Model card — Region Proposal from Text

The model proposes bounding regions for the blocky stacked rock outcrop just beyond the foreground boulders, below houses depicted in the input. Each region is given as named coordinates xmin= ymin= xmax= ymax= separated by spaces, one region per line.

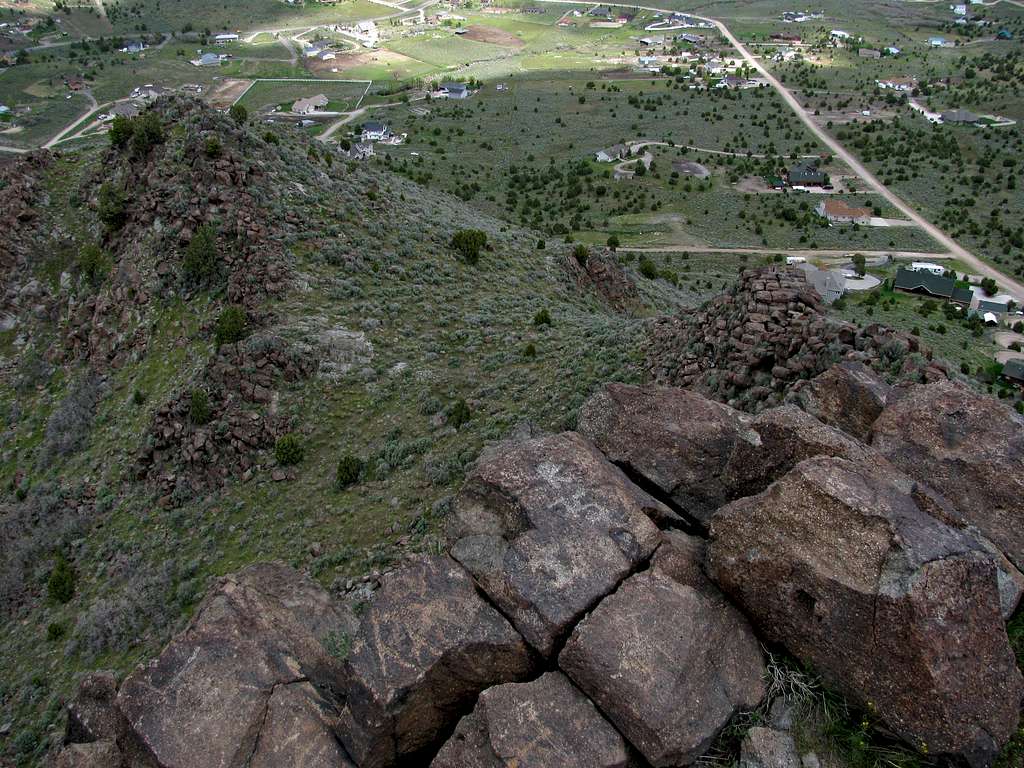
xmin=647 ymin=267 xmax=946 ymax=412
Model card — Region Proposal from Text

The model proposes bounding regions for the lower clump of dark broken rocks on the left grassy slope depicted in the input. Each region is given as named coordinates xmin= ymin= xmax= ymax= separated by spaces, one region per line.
xmin=136 ymin=334 xmax=317 ymax=495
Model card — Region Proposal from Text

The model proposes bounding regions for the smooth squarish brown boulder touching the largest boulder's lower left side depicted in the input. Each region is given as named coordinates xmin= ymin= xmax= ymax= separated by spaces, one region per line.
xmin=558 ymin=540 xmax=765 ymax=768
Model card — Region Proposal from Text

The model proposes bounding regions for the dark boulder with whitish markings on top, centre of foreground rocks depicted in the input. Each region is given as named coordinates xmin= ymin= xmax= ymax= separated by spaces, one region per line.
xmin=449 ymin=432 xmax=671 ymax=656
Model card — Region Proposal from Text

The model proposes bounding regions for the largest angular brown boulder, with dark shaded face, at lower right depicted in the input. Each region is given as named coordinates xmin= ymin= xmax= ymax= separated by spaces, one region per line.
xmin=709 ymin=458 xmax=1024 ymax=766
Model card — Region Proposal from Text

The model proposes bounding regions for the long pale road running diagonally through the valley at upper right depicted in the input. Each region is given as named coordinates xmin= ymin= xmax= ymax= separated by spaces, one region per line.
xmin=538 ymin=0 xmax=1024 ymax=301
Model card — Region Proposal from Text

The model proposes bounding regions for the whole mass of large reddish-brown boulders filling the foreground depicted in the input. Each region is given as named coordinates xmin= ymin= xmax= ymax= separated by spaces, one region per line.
xmin=57 ymin=360 xmax=1024 ymax=768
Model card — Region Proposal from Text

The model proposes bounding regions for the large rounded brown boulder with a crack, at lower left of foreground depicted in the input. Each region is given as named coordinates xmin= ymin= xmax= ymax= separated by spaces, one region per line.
xmin=118 ymin=563 xmax=355 ymax=768
